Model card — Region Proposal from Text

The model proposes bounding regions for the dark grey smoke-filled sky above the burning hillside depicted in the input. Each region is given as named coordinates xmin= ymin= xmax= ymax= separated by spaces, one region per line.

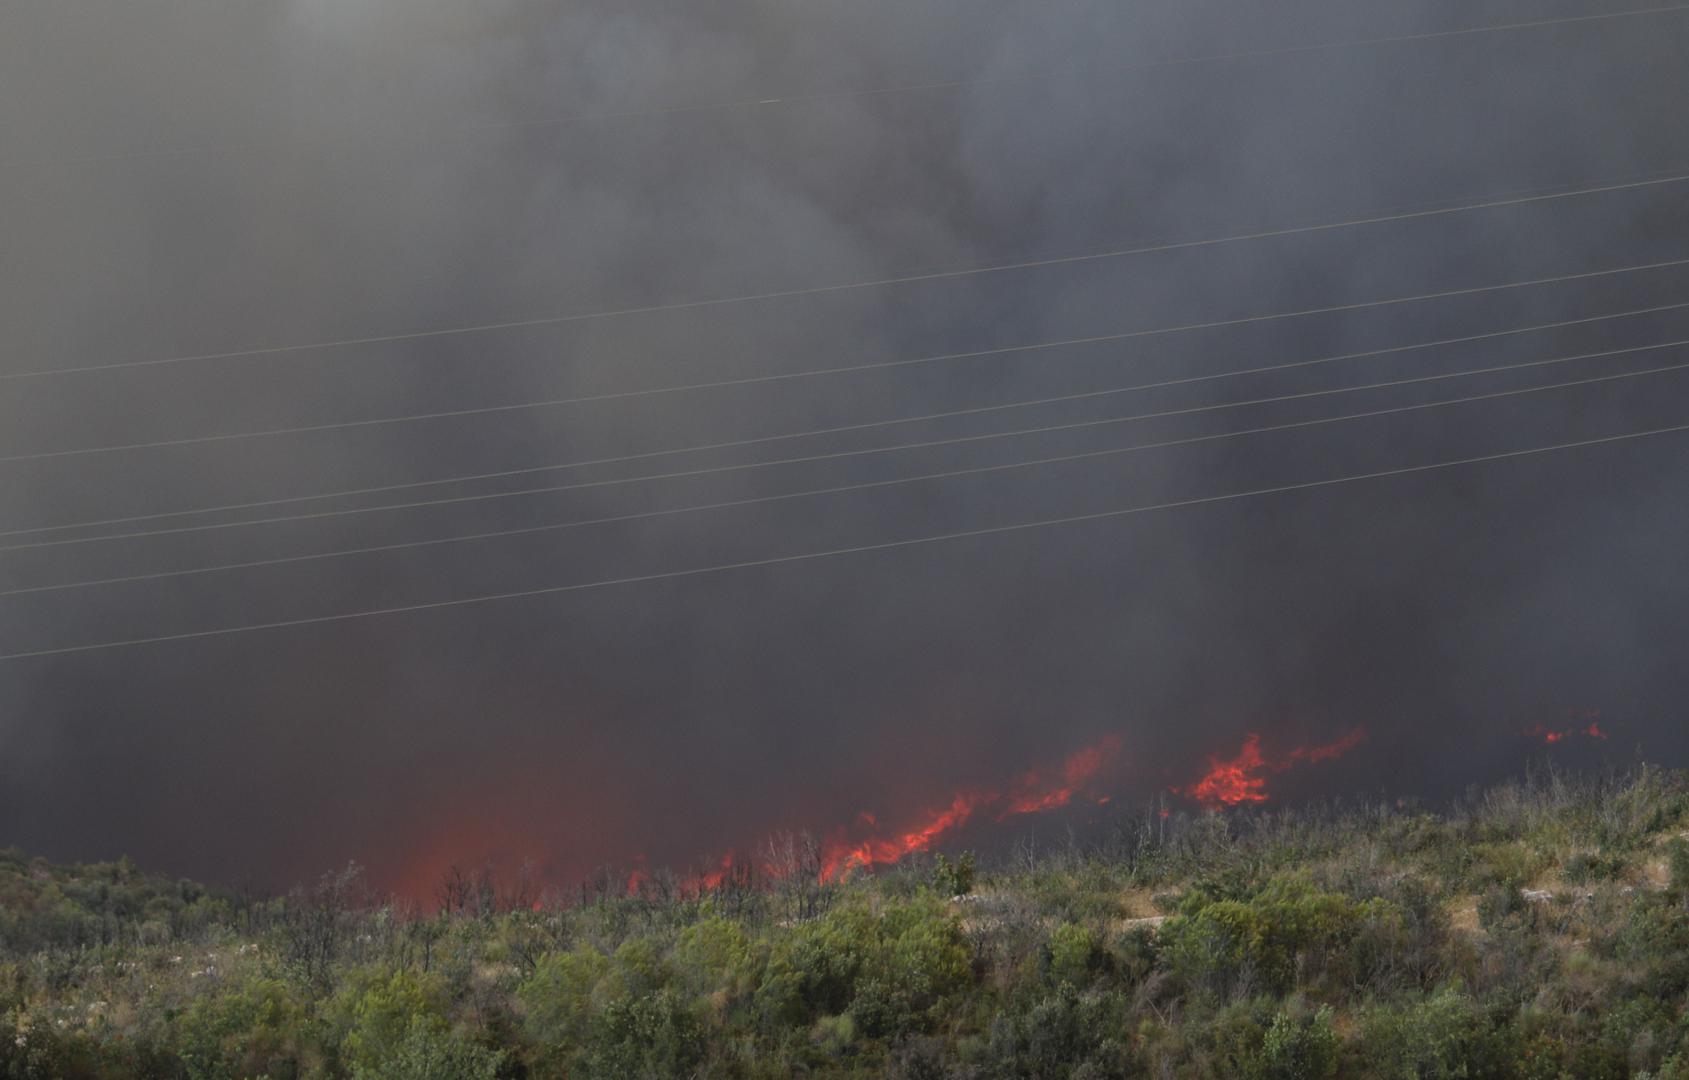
xmin=0 ymin=0 xmax=1689 ymax=894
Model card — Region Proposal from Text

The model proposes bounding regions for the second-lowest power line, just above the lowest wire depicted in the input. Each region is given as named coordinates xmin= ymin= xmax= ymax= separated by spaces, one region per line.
xmin=0 ymin=351 xmax=1689 ymax=597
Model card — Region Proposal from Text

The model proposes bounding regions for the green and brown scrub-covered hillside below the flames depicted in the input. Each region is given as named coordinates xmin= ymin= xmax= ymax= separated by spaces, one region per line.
xmin=0 ymin=767 xmax=1689 ymax=1080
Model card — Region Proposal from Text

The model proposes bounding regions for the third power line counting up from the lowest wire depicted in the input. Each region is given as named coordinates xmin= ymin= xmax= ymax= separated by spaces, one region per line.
xmin=13 ymin=335 xmax=1689 ymax=553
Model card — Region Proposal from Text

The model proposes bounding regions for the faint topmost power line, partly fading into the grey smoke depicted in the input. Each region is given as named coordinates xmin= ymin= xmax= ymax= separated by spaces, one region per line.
xmin=0 ymin=3 xmax=1689 ymax=169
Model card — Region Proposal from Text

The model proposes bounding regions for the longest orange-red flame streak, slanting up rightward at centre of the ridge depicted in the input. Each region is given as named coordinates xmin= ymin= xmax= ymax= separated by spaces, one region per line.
xmin=821 ymin=735 xmax=1121 ymax=881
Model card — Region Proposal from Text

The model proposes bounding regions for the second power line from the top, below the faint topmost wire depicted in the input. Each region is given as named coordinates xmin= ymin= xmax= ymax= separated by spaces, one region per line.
xmin=0 ymin=172 xmax=1689 ymax=380
